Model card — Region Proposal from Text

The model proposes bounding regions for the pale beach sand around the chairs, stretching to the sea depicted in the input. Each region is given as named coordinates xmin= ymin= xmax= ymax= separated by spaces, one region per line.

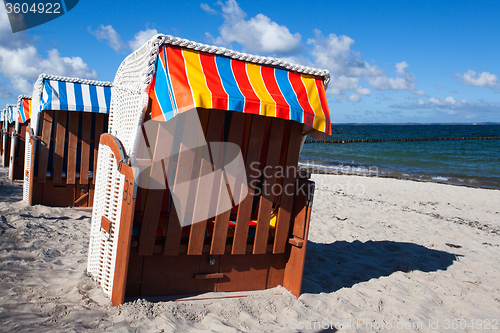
xmin=0 ymin=168 xmax=500 ymax=332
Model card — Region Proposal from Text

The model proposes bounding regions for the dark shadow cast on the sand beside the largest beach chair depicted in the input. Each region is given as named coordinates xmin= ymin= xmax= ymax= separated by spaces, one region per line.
xmin=302 ymin=241 xmax=456 ymax=293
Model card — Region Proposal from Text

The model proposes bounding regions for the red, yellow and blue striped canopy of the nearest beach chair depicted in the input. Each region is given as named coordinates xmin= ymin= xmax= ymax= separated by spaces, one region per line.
xmin=149 ymin=44 xmax=331 ymax=135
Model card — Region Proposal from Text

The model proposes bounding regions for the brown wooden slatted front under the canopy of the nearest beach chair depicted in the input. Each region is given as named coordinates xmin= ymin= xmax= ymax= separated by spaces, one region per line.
xmin=136 ymin=109 xmax=302 ymax=255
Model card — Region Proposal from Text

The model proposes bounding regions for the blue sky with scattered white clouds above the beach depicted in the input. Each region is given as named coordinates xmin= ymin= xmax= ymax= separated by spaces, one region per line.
xmin=0 ymin=0 xmax=500 ymax=123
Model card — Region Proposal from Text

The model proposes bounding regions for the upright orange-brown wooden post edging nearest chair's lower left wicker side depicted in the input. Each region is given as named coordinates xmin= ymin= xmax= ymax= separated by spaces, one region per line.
xmin=111 ymin=163 xmax=135 ymax=306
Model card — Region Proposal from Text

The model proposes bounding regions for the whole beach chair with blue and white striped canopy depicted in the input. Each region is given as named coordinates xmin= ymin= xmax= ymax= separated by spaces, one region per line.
xmin=23 ymin=74 xmax=111 ymax=207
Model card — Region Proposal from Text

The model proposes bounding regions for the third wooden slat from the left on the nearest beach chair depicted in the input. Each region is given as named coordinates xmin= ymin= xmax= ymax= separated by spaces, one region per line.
xmin=187 ymin=110 xmax=213 ymax=255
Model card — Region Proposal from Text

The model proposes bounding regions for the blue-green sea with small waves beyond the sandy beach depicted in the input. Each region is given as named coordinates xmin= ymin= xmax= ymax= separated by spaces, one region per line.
xmin=299 ymin=124 xmax=500 ymax=189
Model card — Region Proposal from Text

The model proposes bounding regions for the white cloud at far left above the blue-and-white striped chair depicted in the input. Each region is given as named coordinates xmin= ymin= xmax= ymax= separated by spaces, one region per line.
xmin=0 ymin=11 xmax=97 ymax=97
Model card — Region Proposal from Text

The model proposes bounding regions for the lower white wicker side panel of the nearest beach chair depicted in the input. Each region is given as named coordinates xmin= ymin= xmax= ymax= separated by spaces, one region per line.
xmin=87 ymin=144 xmax=125 ymax=298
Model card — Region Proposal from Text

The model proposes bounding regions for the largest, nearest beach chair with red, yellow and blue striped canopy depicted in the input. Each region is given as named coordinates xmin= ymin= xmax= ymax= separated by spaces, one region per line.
xmin=87 ymin=35 xmax=331 ymax=305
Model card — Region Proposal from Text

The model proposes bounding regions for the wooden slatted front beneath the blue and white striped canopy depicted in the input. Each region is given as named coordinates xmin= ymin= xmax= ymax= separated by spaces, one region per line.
xmin=35 ymin=110 xmax=109 ymax=184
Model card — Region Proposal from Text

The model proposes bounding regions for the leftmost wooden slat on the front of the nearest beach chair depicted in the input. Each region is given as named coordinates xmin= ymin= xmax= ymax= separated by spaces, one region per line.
xmin=139 ymin=119 xmax=173 ymax=256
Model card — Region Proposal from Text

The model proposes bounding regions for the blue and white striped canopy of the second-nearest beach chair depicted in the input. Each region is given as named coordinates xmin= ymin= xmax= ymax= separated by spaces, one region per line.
xmin=40 ymin=79 xmax=111 ymax=114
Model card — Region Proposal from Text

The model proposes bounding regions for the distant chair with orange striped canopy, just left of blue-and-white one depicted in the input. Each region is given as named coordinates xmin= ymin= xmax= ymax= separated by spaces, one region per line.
xmin=9 ymin=95 xmax=31 ymax=182
